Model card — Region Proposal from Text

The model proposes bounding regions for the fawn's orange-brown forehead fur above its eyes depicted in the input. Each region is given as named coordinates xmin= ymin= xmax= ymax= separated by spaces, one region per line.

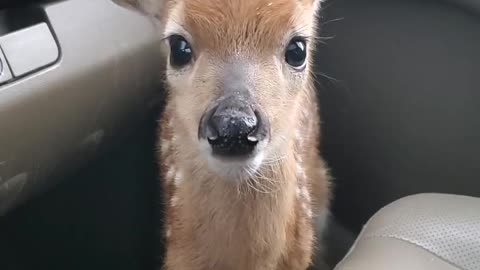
xmin=165 ymin=0 xmax=313 ymax=53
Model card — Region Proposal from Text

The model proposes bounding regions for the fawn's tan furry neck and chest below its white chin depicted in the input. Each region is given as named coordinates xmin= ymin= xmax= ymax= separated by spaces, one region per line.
xmin=162 ymin=88 xmax=313 ymax=269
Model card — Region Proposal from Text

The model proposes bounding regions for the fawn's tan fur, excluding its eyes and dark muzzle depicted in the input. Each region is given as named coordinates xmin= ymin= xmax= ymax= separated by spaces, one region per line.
xmin=115 ymin=0 xmax=330 ymax=270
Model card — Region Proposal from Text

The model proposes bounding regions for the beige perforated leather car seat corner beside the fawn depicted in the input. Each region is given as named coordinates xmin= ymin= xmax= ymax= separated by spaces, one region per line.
xmin=335 ymin=194 xmax=480 ymax=270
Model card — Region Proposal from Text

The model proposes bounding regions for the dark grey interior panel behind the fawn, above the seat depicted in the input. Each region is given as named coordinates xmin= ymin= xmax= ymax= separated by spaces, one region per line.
xmin=317 ymin=0 xmax=480 ymax=232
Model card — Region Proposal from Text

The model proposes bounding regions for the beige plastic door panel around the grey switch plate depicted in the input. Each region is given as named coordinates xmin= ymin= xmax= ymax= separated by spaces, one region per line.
xmin=0 ymin=0 xmax=164 ymax=216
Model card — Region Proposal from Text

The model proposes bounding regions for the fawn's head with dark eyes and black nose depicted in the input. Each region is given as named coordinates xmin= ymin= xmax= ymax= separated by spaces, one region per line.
xmin=115 ymin=0 xmax=320 ymax=181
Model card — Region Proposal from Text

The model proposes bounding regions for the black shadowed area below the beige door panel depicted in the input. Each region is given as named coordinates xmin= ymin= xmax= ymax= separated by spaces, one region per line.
xmin=0 ymin=111 xmax=163 ymax=270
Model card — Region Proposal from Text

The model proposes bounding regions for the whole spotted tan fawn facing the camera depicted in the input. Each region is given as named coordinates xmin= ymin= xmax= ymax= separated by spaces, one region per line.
xmin=115 ymin=0 xmax=330 ymax=270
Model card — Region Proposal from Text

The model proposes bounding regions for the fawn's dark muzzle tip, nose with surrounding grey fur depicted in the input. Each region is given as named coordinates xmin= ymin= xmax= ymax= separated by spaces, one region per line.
xmin=199 ymin=96 xmax=268 ymax=157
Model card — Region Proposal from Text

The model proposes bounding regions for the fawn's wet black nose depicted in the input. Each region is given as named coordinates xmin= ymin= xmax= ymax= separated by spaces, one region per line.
xmin=207 ymin=105 xmax=260 ymax=156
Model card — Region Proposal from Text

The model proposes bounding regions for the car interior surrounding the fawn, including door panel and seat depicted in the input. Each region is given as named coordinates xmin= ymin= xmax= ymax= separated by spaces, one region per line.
xmin=0 ymin=0 xmax=480 ymax=270
